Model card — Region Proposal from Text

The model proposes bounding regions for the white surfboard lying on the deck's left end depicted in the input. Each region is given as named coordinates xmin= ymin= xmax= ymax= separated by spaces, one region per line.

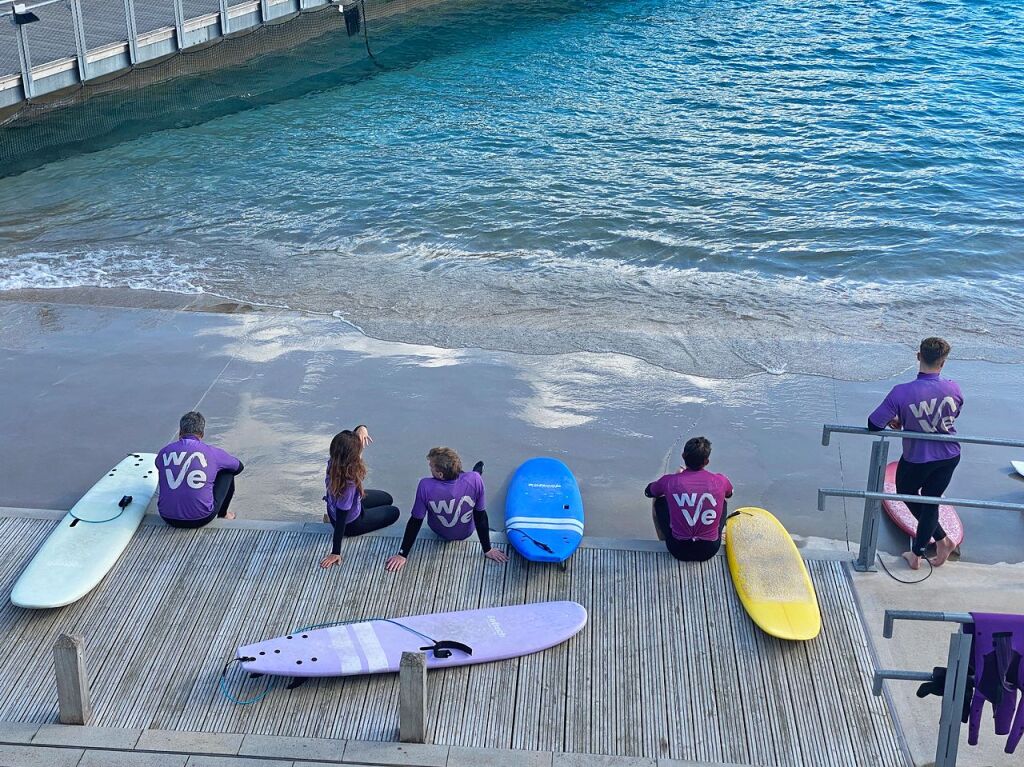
xmin=10 ymin=453 xmax=157 ymax=609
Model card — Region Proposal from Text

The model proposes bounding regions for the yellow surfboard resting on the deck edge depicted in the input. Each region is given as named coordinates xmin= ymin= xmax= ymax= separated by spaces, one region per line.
xmin=725 ymin=506 xmax=821 ymax=639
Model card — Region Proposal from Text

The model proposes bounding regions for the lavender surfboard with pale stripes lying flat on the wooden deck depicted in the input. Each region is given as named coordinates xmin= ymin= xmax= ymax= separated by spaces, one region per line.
xmin=239 ymin=602 xmax=587 ymax=677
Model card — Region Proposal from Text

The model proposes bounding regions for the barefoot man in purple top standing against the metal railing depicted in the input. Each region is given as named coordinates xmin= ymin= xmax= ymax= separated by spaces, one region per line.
xmin=867 ymin=338 xmax=964 ymax=570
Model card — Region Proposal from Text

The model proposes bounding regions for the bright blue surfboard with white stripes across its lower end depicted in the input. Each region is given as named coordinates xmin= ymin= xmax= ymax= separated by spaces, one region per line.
xmin=505 ymin=458 xmax=583 ymax=562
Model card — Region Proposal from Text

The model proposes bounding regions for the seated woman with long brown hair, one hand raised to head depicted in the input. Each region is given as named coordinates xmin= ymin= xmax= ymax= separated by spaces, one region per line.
xmin=321 ymin=426 xmax=399 ymax=568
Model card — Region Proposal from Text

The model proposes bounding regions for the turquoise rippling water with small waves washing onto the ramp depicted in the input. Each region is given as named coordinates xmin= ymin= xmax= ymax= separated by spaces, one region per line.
xmin=0 ymin=0 xmax=1024 ymax=377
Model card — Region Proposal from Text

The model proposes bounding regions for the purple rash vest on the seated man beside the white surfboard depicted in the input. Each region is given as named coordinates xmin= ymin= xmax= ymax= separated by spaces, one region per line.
xmin=156 ymin=434 xmax=242 ymax=521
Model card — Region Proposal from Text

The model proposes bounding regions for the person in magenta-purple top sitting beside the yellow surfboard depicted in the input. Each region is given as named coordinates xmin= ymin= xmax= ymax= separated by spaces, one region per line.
xmin=644 ymin=437 xmax=732 ymax=561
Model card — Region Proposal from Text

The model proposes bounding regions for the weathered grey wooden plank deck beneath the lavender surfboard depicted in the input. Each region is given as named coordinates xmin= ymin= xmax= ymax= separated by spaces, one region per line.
xmin=0 ymin=517 xmax=904 ymax=767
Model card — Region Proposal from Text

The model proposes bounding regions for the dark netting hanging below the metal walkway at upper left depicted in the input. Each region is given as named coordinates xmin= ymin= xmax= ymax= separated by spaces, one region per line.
xmin=0 ymin=0 xmax=465 ymax=175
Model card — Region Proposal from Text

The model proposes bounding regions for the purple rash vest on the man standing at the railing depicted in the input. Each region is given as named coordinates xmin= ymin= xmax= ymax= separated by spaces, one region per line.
xmin=867 ymin=373 xmax=964 ymax=464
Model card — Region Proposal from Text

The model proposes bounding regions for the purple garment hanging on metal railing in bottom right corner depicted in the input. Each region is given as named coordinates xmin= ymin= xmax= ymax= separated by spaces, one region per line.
xmin=968 ymin=612 xmax=1024 ymax=753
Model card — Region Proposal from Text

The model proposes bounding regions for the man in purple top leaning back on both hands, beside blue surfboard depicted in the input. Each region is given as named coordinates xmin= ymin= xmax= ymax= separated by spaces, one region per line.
xmin=384 ymin=448 xmax=508 ymax=572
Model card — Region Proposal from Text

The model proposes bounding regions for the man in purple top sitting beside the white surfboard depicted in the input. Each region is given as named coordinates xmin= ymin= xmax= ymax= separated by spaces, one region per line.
xmin=156 ymin=411 xmax=243 ymax=527
